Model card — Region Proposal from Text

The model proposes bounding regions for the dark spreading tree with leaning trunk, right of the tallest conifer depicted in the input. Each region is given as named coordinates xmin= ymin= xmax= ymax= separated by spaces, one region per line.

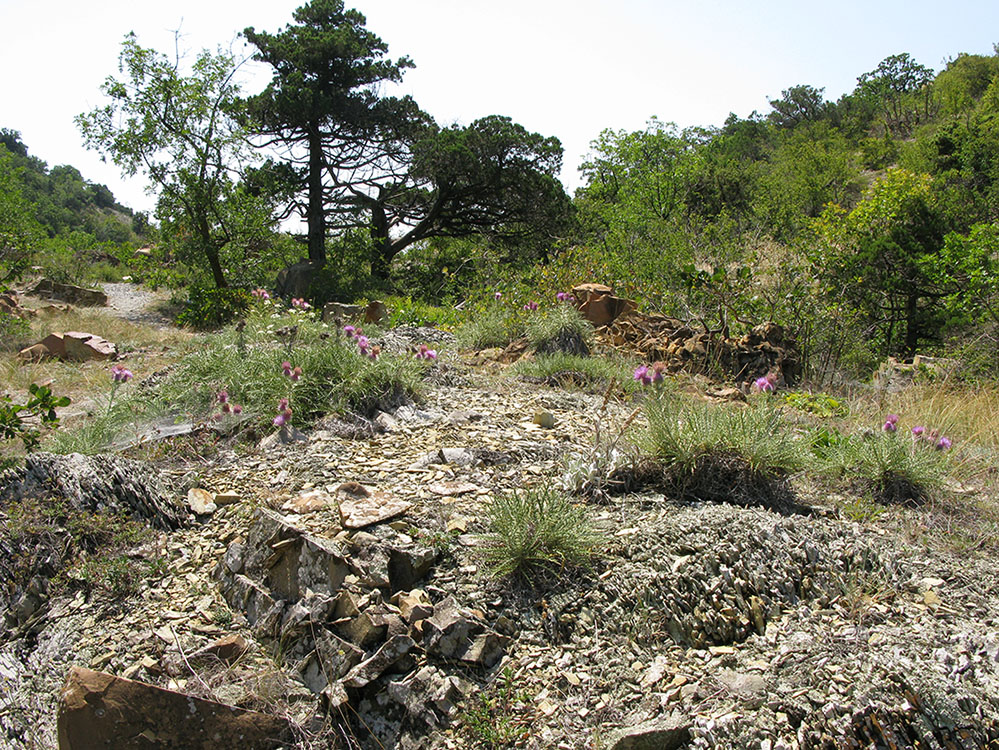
xmin=360 ymin=115 xmax=571 ymax=279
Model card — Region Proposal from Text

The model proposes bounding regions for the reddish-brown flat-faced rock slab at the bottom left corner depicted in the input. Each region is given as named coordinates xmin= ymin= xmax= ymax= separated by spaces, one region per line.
xmin=57 ymin=667 xmax=292 ymax=750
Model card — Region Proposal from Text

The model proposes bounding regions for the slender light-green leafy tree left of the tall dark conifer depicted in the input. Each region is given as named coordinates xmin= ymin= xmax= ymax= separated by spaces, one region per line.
xmin=76 ymin=34 xmax=258 ymax=287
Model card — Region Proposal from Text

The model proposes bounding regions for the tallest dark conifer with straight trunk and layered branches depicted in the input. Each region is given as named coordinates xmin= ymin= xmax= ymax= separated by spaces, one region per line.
xmin=243 ymin=0 xmax=417 ymax=265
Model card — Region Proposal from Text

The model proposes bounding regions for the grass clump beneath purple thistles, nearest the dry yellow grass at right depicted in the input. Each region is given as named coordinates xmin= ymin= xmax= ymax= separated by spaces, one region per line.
xmin=819 ymin=432 xmax=949 ymax=505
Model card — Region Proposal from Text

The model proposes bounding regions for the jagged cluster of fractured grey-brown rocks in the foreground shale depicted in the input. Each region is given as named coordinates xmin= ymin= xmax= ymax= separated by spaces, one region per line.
xmin=216 ymin=510 xmax=510 ymax=726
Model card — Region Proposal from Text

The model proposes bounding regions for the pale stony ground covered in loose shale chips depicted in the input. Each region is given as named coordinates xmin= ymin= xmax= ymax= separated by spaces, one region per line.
xmin=0 ymin=286 xmax=999 ymax=750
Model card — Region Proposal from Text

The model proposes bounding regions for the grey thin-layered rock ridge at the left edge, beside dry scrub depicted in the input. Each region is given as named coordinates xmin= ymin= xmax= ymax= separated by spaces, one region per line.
xmin=0 ymin=453 xmax=188 ymax=529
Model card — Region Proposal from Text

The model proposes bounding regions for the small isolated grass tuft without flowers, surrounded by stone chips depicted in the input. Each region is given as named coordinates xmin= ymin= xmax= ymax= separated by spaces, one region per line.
xmin=484 ymin=488 xmax=600 ymax=576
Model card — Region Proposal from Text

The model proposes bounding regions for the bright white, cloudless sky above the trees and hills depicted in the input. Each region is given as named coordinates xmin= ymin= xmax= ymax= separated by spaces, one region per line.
xmin=0 ymin=0 xmax=999 ymax=216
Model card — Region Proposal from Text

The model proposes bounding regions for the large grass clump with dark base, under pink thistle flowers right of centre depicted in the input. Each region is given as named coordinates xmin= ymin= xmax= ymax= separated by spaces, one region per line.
xmin=644 ymin=393 xmax=801 ymax=508
